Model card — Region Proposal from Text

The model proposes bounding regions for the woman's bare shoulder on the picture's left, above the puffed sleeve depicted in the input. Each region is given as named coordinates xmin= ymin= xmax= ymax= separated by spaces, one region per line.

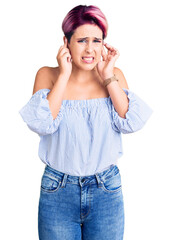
xmin=32 ymin=66 xmax=58 ymax=94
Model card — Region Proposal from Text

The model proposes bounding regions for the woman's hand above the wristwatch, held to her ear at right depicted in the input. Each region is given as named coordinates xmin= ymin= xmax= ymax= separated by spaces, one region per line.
xmin=96 ymin=43 xmax=120 ymax=80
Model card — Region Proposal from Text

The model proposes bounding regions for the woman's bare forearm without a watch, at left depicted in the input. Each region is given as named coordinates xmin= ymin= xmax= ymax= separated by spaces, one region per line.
xmin=47 ymin=74 xmax=69 ymax=119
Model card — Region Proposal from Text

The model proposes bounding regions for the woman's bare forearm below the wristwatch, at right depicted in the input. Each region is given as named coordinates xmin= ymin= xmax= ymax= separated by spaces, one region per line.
xmin=106 ymin=81 xmax=129 ymax=118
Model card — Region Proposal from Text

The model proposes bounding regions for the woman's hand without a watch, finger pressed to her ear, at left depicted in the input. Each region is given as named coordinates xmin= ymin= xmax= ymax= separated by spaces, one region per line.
xmin=56 ymin=37 xmax=72 ymax=77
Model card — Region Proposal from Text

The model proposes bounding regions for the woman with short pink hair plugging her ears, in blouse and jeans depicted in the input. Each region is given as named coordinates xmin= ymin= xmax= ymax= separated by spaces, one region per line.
xmin=20 ymin=5 xmax=152 ymax=240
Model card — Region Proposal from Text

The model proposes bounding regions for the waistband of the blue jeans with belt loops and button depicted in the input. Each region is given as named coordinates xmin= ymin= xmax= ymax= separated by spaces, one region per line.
xmin=44 ymin=164 xmax=119 ymax=187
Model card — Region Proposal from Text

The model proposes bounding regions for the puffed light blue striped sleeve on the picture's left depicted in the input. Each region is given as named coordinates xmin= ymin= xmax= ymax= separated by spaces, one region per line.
xmin=19 ymin=89 xmax=64 ymax=135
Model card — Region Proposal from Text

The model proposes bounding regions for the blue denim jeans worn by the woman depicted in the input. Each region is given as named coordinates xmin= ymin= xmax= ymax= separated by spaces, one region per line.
xmin=38 ymin=165 xmax=124 ymax=240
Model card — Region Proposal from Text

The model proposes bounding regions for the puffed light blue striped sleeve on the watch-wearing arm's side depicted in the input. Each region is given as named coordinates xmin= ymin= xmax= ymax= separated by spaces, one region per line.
xmin=112 ymin=88 xmax=153 ymax=134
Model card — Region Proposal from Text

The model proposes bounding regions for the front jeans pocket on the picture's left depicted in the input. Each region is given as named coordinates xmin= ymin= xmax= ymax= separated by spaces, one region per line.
xmin=41 ymin=174 xmax=61 ymax=192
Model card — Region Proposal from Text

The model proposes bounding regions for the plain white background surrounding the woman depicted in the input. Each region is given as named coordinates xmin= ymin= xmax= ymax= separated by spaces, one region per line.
xmin=0 ymin=0 xmax=172 ymax=240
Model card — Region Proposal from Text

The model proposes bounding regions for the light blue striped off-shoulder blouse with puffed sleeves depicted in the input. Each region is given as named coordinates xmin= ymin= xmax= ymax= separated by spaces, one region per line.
xmin=19 ymin=88 xmax=152 ymax=176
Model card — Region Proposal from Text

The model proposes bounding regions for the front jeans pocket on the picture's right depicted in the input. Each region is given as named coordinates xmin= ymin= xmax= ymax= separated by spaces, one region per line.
xmin=102 ymin=173 xmax=122 ymax=193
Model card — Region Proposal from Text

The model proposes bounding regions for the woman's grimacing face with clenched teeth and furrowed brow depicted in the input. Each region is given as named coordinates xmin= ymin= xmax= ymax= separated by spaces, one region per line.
xmin=68 ymin=24 xmax=103 ymax=70
